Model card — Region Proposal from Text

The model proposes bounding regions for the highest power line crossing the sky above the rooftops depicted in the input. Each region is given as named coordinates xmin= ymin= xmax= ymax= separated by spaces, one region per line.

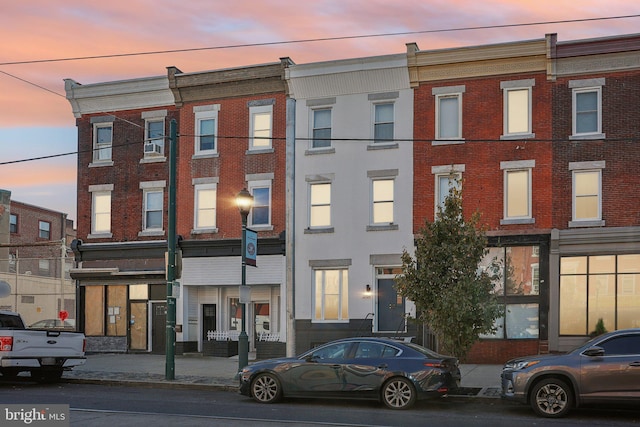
xmin=0 ymin=15 xmax=640 ymax=66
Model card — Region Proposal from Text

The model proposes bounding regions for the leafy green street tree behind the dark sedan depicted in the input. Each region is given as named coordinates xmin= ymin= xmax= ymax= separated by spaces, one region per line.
xmin=396 ymin=176 xmax=503 ymax=360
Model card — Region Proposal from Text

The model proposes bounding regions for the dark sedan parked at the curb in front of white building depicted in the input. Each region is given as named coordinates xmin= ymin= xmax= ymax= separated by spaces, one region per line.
xmin=240 ymin=338 xmax=460 ymax=409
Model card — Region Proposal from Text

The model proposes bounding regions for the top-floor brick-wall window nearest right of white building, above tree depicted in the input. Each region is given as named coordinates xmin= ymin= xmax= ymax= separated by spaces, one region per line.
xmin=432 ymin=86 xmax=465 ymax=143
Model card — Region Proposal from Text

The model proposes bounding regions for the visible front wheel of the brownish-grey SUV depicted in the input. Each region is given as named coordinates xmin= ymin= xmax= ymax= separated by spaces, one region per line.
xmin=530 ymin=378 xmax=573 ymax=418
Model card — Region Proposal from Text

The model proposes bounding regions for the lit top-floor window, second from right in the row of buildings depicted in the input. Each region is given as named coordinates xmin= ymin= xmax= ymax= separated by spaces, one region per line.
xmin=500 ymin=79 xmax=535 ymax=139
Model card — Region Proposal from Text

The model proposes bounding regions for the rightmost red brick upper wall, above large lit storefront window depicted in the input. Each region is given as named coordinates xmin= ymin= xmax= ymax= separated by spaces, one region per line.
xmin=553 ymin=71 xmax=640 ymax=229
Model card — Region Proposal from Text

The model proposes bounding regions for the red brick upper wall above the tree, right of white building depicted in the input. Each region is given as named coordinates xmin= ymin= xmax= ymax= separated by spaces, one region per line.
xmin=414 ymin=75 xmax=552 ymax=234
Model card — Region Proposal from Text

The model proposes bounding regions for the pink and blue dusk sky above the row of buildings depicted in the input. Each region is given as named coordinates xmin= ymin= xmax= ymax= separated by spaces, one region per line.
xmin=0 ymin=0 xmax=640 ymax=224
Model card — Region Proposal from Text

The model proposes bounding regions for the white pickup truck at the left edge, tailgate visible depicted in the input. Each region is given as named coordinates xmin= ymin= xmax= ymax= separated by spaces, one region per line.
xmin=0 ymin=310 xmax=86 ymax=382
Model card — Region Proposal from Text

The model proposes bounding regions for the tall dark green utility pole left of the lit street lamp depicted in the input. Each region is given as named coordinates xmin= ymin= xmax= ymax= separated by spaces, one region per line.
xmin=165 ymin=119 xmax=178 ymax=380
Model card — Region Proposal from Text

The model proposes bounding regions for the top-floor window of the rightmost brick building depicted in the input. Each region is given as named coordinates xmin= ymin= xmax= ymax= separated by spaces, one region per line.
xmin=569 ymin=78 xmax=605 ymax=139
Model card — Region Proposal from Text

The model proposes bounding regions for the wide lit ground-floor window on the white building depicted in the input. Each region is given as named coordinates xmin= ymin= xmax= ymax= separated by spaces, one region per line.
xmin=313 ymin=269 xmax=349 ymax=320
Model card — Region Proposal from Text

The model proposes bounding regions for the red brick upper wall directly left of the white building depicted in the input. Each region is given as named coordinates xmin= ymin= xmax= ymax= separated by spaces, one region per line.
xmin=177 ymin=93 xmax=286 ymax=239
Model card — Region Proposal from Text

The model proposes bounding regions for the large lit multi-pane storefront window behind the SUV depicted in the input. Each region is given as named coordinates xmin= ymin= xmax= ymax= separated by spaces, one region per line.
xmin=559 ymin=254 xmax=640 ymax=336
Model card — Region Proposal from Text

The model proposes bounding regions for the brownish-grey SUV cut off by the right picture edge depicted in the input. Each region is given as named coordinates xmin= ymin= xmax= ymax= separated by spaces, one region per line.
xmin=501 ymin=329 xmax=640 ymax=418
